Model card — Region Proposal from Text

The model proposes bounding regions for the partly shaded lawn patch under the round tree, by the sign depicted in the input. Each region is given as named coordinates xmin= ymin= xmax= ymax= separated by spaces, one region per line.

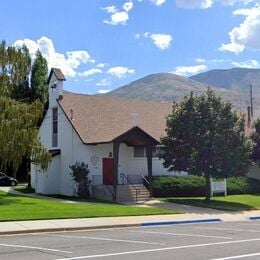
xmin=161 ymin=194 xmax=260 ymax=211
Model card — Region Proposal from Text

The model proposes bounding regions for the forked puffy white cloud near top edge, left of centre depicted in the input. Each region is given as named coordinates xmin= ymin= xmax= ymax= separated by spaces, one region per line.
xmin=102 ymin=1 xmax=134 ymax=25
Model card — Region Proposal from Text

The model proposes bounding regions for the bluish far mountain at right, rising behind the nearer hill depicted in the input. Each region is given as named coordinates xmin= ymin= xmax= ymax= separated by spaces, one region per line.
xmin=190 ymin=68 xmax=260 ymax=93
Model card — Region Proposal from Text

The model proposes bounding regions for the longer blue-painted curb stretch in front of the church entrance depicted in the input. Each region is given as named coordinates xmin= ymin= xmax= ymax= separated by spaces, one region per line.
xmin=141 ymin=217 xmax=222 ymax=227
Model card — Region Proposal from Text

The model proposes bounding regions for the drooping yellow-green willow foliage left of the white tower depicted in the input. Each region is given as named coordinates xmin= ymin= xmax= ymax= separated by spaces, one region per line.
xmin=0 ymin=96 xmax=51 ymax=174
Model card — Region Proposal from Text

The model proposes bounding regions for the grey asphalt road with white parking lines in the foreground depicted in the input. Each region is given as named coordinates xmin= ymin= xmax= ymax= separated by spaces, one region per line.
xmin=0 ymin=221 xmax=260 ymax=260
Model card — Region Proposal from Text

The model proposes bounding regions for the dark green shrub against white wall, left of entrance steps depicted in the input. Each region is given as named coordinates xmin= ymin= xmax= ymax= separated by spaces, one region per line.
xmin=69 ymin=162 xmax=91 ymax=198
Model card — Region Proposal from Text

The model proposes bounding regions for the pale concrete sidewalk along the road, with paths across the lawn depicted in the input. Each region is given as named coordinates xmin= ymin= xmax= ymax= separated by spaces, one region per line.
xmin=0 ymin=187 xmax=260 ymax=235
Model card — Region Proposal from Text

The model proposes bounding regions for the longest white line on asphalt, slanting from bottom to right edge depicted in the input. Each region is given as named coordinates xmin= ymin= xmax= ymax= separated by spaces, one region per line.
xmin=56 ymin=238 xmax=260 ymax=260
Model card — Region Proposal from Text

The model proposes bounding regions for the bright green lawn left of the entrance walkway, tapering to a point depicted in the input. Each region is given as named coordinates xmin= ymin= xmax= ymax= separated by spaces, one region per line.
xmin=0 ymin=191 xmax=182 ymax=221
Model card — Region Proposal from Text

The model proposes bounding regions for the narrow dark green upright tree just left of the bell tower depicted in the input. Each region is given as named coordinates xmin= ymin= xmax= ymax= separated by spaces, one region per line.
xmin=31 ymin=50 xmax=48 ymax=106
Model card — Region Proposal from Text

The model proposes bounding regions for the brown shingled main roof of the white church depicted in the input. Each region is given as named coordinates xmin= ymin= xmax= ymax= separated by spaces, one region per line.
xmin=59 ymin=93 xmax=172 ymax=144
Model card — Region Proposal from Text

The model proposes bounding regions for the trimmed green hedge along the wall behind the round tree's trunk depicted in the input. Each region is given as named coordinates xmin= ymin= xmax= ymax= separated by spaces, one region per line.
xmin=153 ymin=176 xmax=260 ymax=197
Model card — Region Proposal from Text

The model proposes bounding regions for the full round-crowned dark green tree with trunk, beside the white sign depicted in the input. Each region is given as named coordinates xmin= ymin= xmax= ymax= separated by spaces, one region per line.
xmin=161 ymin=89 xmax=250 ymax=200
